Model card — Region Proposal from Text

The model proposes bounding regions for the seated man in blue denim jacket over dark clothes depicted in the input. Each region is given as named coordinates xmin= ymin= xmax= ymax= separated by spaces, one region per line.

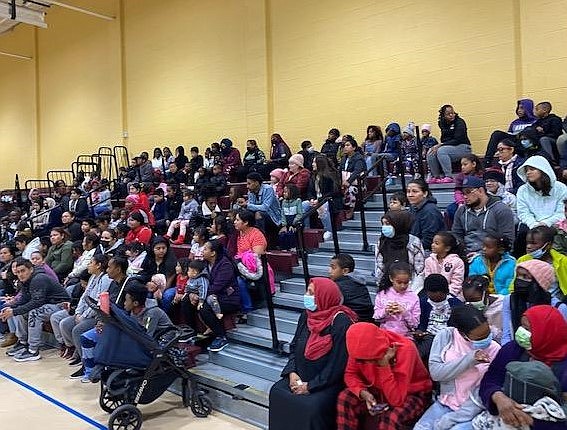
xmin=242 ymin=172 xmax=282 ymax=244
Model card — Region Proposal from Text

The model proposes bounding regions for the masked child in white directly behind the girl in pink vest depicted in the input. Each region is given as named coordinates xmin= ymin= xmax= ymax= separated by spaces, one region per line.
xmin=463 ymin=275 xmax=504 ymax=344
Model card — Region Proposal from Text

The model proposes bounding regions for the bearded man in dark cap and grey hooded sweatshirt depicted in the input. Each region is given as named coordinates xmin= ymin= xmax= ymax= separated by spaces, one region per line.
xmin=453 ymin=176 xmax=515 ymax=253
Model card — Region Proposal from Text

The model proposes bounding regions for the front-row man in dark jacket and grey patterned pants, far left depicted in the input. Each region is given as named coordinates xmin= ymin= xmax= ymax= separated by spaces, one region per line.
xmin=0 ymin=258 xmax=69 ymax=361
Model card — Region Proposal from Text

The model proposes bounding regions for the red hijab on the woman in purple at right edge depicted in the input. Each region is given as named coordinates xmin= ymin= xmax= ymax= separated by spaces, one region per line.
xmin=524 ymin=305 xmax=567 ymax=366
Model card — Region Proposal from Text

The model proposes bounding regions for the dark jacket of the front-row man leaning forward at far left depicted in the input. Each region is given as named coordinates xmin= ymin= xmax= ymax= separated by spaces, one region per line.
xmin=13 ymin=267 xmax=70 ymax=315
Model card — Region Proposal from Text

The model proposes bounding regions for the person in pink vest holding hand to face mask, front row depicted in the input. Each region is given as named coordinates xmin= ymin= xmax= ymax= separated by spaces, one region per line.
xmin=414 ymin=305 xmax=500 ymax=430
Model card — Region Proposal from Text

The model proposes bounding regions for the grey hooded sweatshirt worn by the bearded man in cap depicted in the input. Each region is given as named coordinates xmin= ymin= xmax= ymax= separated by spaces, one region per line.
xmin=453 ymin=195 xmax=516 ymax=252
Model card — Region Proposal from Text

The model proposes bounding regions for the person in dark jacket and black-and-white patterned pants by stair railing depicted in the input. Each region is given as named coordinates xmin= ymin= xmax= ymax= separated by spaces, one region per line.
xmin=340 ymin=135 xmax=366 ymax=219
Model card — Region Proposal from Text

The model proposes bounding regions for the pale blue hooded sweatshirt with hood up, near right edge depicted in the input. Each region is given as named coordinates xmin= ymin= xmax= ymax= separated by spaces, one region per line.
xmin=516 ymin=155 xmax=567 ymax=229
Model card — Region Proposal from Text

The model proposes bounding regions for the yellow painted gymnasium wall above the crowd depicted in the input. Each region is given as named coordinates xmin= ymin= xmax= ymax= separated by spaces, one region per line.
xmin=0 ymin=0 xmax=567 ymax=187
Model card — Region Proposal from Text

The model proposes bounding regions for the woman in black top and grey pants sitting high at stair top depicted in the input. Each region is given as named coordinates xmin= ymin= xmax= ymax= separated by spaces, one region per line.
xmin=427 ymin=105 xmax=471 ymax=184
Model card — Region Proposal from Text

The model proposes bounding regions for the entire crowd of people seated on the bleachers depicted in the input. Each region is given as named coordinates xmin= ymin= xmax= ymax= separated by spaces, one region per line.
xmin=0 ymin=100 xmax=567 ymax=430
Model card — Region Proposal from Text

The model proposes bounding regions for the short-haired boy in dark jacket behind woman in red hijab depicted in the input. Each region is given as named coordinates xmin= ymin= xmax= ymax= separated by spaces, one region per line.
xmin=329 ymin=254 xmax=374 ymax=322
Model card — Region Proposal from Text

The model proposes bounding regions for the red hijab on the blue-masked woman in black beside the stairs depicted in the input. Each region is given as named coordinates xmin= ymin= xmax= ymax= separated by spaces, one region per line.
xmin=305 ymin=278 xmax=357 ymax=360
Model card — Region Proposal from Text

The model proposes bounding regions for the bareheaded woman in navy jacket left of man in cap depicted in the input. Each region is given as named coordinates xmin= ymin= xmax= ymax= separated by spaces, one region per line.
xmin=406 ymin=179 xmax=445 ymax=251
